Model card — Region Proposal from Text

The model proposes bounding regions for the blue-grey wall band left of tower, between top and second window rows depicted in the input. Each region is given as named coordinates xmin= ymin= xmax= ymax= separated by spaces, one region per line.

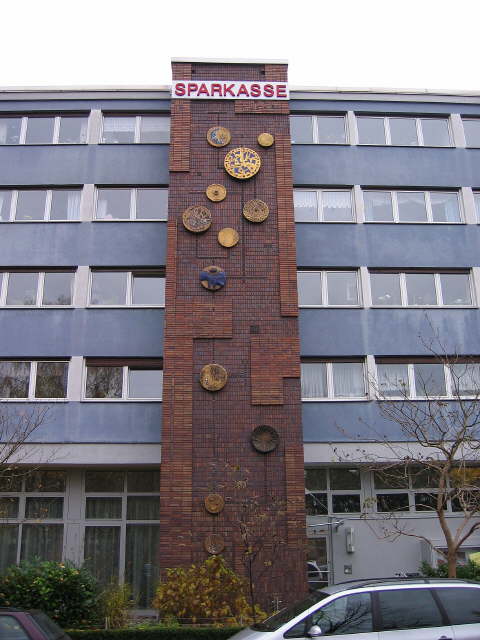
xmin=0 ymin=144 xmax=169 ymax=186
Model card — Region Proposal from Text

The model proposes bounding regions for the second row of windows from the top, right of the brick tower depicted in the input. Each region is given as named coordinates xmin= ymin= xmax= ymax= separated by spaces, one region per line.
xmin=293 ymin=189 xmax=480 ymax=224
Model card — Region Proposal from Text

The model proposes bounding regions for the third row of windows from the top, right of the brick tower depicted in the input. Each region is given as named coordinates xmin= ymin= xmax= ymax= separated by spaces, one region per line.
xmin=297 ymin=269 xmax=475 ymax=307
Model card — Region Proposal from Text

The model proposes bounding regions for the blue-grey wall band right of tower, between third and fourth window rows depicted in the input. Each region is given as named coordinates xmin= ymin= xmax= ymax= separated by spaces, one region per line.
xmin=300 ymin=309 xmax=480 ymax=357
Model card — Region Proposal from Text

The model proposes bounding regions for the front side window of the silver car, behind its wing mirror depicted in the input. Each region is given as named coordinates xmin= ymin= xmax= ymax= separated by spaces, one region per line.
xmin=312 ymin=593 xmax=373 ymax=636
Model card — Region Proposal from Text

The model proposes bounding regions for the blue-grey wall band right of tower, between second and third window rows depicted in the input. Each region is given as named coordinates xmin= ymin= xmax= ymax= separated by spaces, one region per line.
xmin=295 ymin=223 xmax=480 ymax=268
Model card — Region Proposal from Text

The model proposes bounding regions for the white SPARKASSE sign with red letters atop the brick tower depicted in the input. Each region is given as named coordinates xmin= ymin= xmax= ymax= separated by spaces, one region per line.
xmin=172 ymin=80 xmax=289 ymax=100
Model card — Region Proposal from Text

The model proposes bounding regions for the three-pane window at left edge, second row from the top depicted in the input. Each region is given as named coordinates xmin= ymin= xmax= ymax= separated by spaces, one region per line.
xmin=0 ymin=188 xmax=82 ymax=222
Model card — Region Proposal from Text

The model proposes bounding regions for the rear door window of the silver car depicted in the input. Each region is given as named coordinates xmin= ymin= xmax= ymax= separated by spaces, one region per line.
xmin=378 ymin=589 xmax=443 ymax=631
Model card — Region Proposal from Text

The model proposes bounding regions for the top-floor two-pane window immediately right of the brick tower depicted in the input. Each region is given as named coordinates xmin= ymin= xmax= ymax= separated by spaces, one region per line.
xmin=290 ymin=114 xmax=347 ymax=144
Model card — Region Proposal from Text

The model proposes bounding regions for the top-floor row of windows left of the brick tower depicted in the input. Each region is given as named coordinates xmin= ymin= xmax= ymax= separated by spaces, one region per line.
xmin=0 ymin=114 xmax=170 ymax=145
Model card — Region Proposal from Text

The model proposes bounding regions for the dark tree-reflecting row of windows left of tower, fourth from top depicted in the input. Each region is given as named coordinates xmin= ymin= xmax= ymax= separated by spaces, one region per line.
xmin=0 ymin=360 xmax=163 ymax=400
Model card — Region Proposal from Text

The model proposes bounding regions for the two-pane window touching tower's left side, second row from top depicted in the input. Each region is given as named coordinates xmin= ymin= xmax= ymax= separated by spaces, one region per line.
xmin=95 ymin=187 xmax=168 ymax=220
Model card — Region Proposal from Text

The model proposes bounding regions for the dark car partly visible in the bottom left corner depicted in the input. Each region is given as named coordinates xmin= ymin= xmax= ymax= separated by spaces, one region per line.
xmin=0 ymin=607 xmax=70 ymax=640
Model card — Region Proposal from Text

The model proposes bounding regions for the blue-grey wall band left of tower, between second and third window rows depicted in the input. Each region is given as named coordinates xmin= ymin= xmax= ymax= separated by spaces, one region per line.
xmin=0 ymin=222 xmax=167 ymax=267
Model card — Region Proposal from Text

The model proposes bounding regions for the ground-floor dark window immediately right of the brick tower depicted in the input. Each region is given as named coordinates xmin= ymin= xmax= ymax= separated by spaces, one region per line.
xmin=305 ymin=467 xmax=362 ymax=516
